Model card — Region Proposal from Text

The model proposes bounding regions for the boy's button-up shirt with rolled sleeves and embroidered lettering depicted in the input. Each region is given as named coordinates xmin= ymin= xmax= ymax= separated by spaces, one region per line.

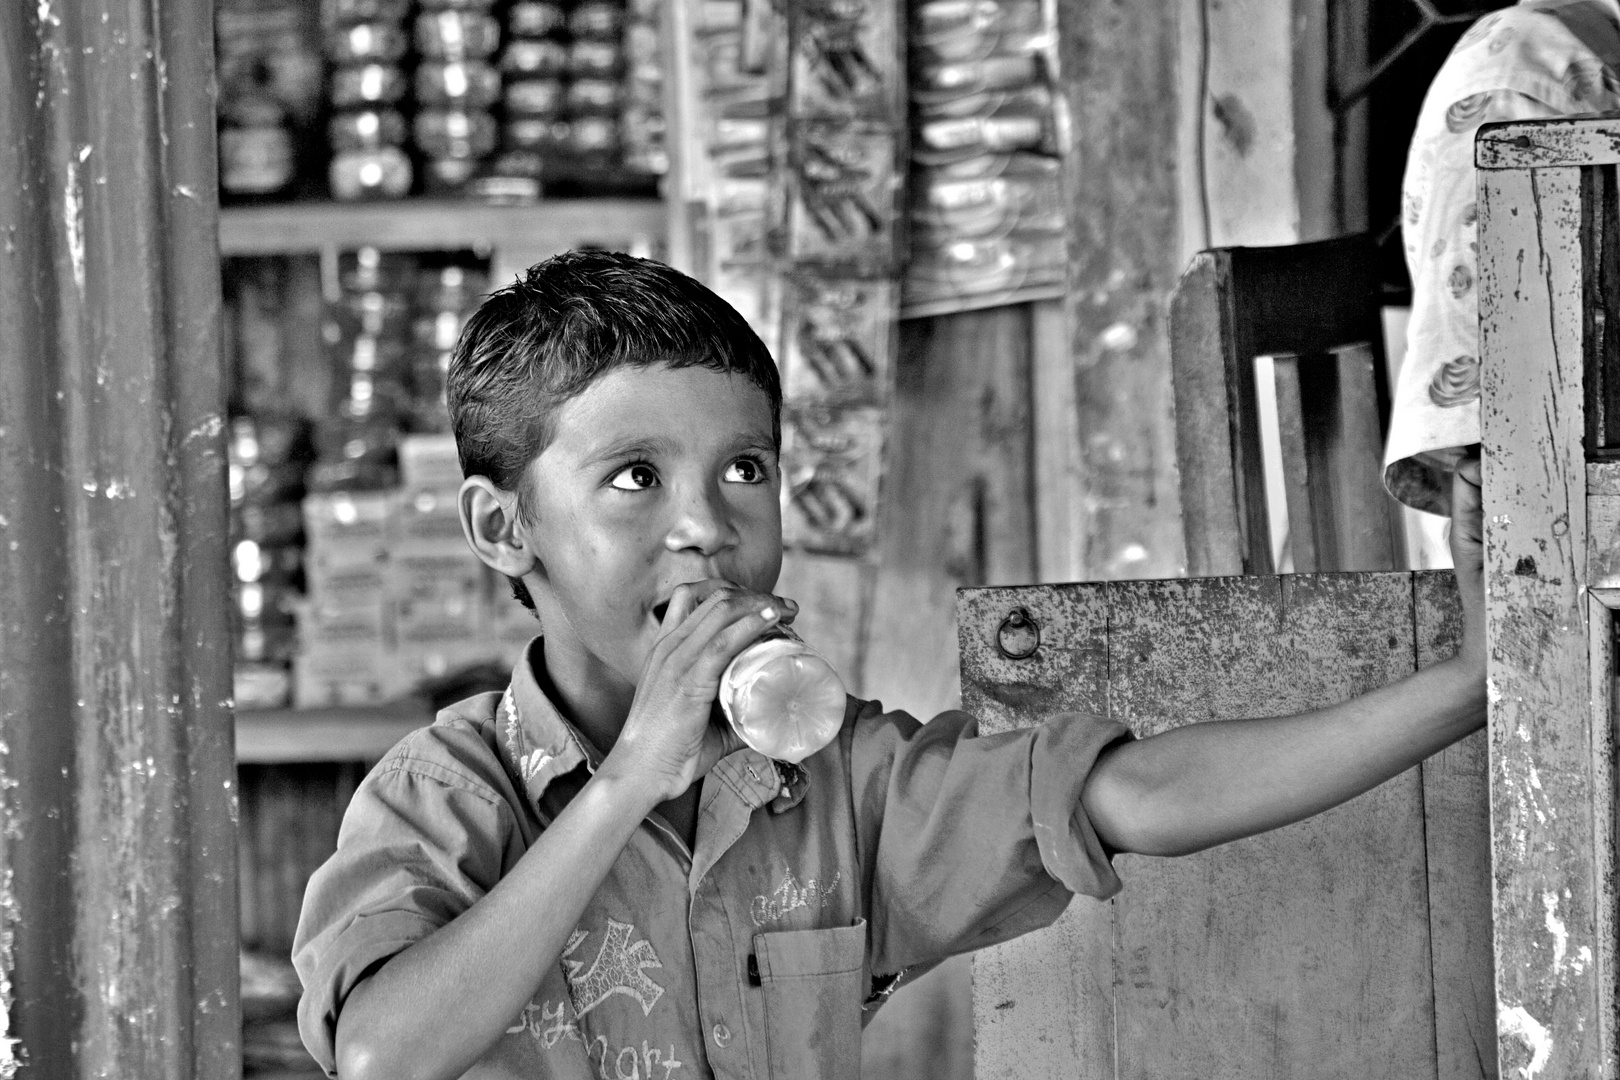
xmin=293 ymin=644 xmax=1129 ymax=1080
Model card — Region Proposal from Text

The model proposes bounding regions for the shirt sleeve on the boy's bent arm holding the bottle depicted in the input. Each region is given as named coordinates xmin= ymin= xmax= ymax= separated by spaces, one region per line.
xmin=293 ymin=725 xmax=522 ymax=1077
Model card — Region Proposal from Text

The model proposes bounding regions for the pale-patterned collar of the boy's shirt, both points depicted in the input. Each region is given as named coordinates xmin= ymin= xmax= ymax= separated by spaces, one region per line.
xmin=496 ymin=638 xmax=810 ymax=813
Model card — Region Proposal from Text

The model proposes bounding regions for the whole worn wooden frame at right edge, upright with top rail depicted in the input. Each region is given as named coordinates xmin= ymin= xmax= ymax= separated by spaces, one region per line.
xmin=1476 ymin=118 xmax=1620 ymax=1080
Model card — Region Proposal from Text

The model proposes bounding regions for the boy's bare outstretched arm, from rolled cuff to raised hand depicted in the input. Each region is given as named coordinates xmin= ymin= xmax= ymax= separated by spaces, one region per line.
xmin=1081 ymin=458 xmax=1486 ymax=855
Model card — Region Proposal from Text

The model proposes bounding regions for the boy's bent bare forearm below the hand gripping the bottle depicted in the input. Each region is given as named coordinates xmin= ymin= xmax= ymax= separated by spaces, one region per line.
xmin=337 ymin=763 xmax=653 ymax=1080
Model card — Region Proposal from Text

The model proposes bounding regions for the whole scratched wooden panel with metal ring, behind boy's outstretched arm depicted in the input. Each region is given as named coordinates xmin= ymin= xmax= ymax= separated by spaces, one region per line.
xmin=959 ymin=573 xmax=1492 ymax=1078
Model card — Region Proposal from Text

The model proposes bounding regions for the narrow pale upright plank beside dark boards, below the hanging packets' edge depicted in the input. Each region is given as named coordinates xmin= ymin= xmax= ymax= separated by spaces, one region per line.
xmin=1030 ymin=301 xmax=1085 ymax=581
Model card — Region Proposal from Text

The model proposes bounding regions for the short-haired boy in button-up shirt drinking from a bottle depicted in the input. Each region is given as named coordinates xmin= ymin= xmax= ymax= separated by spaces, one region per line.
xmin=295 ymin=253 xmax=1484 ymax=1080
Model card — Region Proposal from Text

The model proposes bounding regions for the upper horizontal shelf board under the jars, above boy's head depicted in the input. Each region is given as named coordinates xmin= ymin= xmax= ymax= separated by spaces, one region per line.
xmin=219 ymin=199 xmax=666 ymax=256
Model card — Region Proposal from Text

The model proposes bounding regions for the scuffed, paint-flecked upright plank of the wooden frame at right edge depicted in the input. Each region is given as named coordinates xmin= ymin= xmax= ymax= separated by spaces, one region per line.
xmin=1479 ymin=162 xmax=1615 ymax=1077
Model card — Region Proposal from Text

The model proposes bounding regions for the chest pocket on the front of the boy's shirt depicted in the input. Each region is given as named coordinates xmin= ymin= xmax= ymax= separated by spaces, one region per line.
xmin=753 ymin=918 xmax=867 ymax=1080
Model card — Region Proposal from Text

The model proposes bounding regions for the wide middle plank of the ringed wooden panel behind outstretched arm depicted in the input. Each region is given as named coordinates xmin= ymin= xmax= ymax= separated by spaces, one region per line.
xmin=1102 ymin=573 xmax=1435 ymax=1080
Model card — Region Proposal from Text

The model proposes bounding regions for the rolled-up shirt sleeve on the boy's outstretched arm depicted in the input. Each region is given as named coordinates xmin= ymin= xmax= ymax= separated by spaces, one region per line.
xmin=851 ymin=703 xmax=1131 ymax=973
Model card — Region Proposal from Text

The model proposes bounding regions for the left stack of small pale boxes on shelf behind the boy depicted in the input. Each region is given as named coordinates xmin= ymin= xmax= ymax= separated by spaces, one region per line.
xmin=293 ymin=491 xmax=402 ymax=709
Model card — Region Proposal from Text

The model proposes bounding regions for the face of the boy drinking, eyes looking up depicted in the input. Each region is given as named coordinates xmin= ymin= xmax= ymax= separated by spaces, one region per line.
xmin=511 ymin=364 xmax=782 ymax=687
